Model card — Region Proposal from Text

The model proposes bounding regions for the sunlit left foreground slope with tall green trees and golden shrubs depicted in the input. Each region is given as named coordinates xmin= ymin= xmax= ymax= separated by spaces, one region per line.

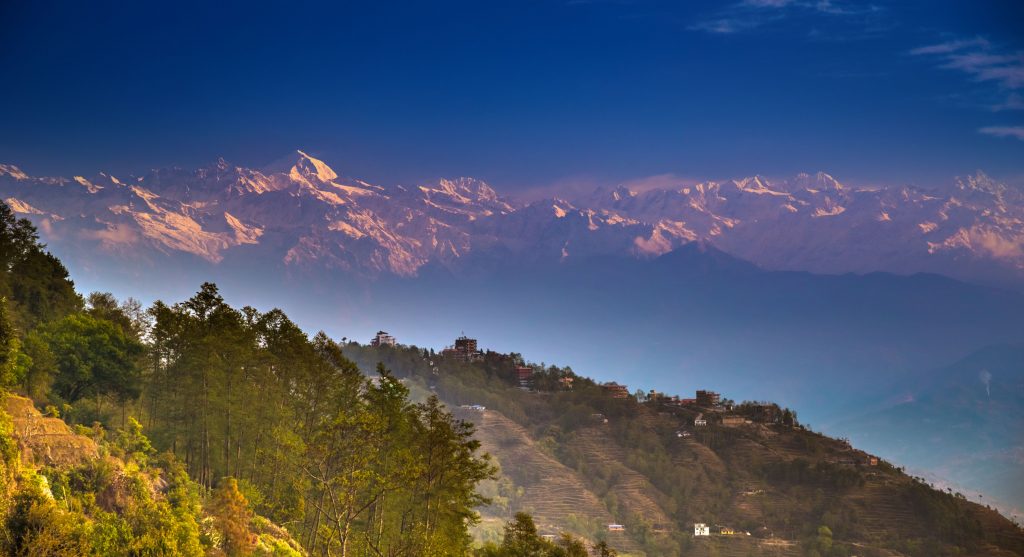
xmin=0 ymin=205 xmax=493 ymax=555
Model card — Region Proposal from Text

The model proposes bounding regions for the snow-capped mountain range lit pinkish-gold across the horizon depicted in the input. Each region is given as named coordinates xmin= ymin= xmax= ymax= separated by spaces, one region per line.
xmin=0 ymin=152 xmax=1024 ymax=288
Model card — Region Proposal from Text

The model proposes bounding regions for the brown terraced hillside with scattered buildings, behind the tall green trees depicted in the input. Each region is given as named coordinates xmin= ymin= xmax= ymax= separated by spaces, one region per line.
xmin=346 ymin=335 xmax=1024 ymax=556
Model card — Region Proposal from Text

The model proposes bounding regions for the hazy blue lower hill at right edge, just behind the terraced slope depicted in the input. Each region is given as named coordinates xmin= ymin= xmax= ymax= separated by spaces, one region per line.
xmin=835 ymin=344 xmax=1024 ymax=520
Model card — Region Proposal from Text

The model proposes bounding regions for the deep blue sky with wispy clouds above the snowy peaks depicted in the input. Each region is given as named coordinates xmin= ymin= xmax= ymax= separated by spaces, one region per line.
xmin=0 ymin=0 xmax=1024 ymax=192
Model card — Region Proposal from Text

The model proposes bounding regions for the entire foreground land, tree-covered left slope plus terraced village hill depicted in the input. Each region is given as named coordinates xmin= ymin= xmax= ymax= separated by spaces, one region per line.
xmin=0 ymin=204 xmax=1024 ymax=557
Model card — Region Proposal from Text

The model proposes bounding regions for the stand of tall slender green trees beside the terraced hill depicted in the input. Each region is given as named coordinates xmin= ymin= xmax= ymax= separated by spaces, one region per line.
xmin=135 ymin=284 xmax=493 ymax=555
